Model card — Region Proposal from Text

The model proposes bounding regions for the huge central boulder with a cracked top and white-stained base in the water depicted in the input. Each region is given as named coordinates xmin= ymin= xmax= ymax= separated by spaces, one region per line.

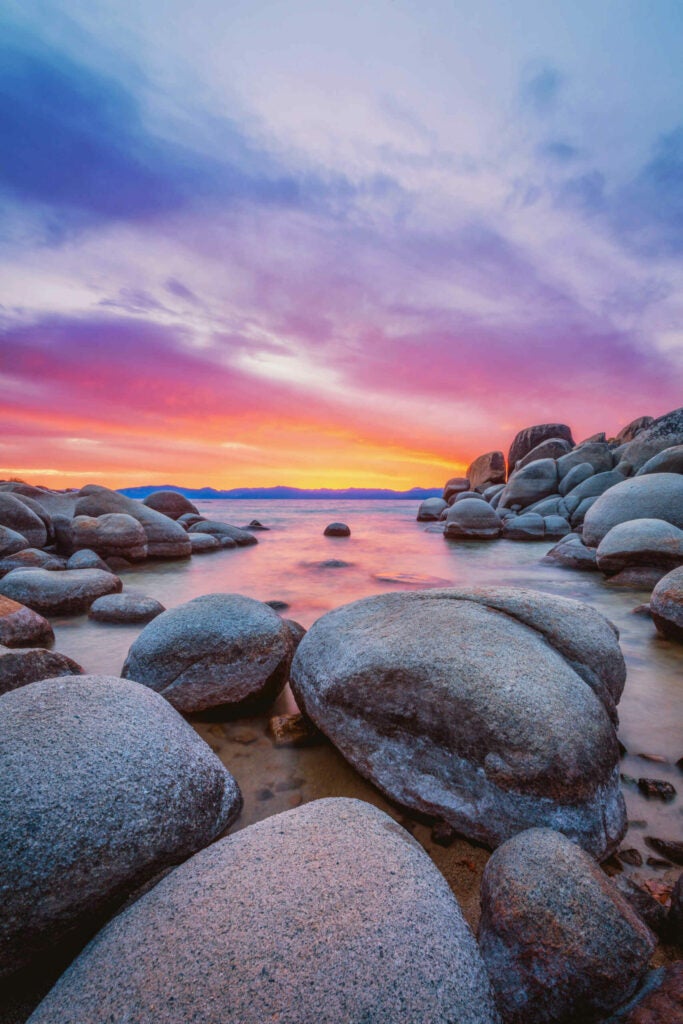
xmin=291 ymin=588 xmax=626 ymax=857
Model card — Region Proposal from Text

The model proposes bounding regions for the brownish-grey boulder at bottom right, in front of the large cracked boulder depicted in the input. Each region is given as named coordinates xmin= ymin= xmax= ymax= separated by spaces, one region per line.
xmin=477 ymin=828 xmax=655 ymax=1024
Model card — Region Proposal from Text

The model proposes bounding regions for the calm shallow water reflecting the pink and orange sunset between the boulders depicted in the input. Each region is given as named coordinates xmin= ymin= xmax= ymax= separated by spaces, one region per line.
xmin=54 ymin=501 xmax=683 ymax=916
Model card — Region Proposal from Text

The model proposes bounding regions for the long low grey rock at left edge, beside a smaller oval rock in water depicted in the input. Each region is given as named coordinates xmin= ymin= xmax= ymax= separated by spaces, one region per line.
xmin=0 ymin=569 xmax=122 ymax=615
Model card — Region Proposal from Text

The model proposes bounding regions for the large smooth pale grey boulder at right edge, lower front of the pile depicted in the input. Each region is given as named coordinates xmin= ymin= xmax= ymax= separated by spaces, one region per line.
xmin=584 ymin=473 xmax=683 ymax=548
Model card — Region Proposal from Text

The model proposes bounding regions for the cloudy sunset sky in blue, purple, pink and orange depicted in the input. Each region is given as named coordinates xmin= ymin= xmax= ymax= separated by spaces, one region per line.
xmin=0 ymin=0 xmax=683 ymax=488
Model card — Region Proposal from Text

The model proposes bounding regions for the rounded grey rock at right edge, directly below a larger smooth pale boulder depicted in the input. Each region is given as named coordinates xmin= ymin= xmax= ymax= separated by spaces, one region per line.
xmin=596 ymin=519 xmax=683 ymax=575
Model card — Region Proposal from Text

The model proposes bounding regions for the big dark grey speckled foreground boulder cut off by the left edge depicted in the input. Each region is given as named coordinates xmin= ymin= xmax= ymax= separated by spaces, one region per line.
xmin=0 ymin=676 xmax=242 ymax=975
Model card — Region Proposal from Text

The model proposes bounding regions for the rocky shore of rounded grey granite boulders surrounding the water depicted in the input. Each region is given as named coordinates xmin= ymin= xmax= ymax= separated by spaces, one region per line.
xmin=0 ymin=410 xmax=683 ymax=1024
